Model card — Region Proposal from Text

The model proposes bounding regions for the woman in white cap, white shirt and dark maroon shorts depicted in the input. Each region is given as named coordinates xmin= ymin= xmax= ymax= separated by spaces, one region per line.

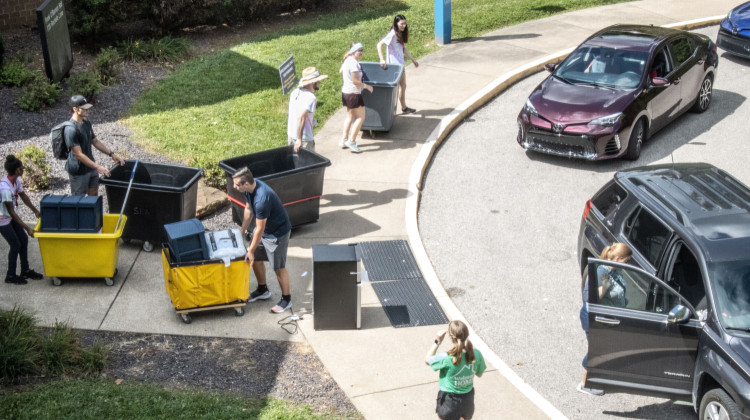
xmin=339 ymin=42 xmax=372 ymax=153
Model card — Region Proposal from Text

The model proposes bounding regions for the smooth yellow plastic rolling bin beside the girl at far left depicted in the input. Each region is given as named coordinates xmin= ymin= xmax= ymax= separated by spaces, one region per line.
xmin=34 ymin=214 xmax=128 ymax=286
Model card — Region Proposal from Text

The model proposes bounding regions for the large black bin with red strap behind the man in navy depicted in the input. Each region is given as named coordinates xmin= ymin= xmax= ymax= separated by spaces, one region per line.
xmin=220 ymin=146 xmax=331 ymax=227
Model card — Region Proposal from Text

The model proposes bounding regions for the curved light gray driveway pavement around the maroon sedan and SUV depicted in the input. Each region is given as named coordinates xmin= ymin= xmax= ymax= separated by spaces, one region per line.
xmin=419 ymin=27 xmax=750 ymax=419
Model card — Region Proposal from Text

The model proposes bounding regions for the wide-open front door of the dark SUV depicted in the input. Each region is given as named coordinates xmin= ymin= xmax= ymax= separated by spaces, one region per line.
xmin=585 ymin=259 xmax=702 ymax=401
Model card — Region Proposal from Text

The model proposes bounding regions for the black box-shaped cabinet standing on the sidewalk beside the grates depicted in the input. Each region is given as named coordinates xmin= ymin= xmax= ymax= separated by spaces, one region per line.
xmin=313 ymin=244 xmax=362 ymax=330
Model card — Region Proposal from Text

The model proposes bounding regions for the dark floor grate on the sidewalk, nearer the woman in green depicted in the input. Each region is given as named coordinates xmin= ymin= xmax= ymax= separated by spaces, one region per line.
xmin=372 ymin=277 xmax=448 ymax=328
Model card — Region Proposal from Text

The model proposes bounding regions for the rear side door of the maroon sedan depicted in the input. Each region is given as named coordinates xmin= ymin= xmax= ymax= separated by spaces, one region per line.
xmin=667 ymin=36 xmax=703 ymax=112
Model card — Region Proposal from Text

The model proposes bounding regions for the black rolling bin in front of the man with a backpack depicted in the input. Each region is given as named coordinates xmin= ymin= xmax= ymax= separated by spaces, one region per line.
xmin=99 ymin=160 xmax=203 ymax=251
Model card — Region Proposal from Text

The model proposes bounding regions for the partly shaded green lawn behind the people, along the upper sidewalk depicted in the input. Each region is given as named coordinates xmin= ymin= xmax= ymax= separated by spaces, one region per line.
xmin=125 ymin=0 xmax=624 ymax=167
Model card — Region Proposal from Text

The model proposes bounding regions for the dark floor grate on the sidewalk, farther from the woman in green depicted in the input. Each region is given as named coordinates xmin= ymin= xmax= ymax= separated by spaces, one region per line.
xmin=359 ymin=240 xmax=422 ymax=281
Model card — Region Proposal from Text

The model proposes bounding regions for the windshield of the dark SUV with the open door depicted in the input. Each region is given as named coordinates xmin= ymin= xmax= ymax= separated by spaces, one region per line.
xmin=708 ymin=260 xmax=750 ymax=330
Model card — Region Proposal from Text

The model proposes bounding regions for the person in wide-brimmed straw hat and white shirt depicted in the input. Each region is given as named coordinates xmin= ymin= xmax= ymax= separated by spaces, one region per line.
xmin=286 ymin=67 xmax=328 ymax=153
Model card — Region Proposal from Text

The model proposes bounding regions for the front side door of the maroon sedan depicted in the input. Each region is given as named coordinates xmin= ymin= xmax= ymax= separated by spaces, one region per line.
xmin=646 ymin=46 xmax=681 ymax=132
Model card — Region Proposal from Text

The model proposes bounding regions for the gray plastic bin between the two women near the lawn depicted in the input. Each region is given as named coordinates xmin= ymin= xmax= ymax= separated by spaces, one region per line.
xmin=359 ymin=62 xmax=404 ymax=131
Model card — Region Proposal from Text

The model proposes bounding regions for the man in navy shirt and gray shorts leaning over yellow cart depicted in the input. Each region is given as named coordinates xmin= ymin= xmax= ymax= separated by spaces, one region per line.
xmin=232 ymin=168 xmax=292 ymax=314
